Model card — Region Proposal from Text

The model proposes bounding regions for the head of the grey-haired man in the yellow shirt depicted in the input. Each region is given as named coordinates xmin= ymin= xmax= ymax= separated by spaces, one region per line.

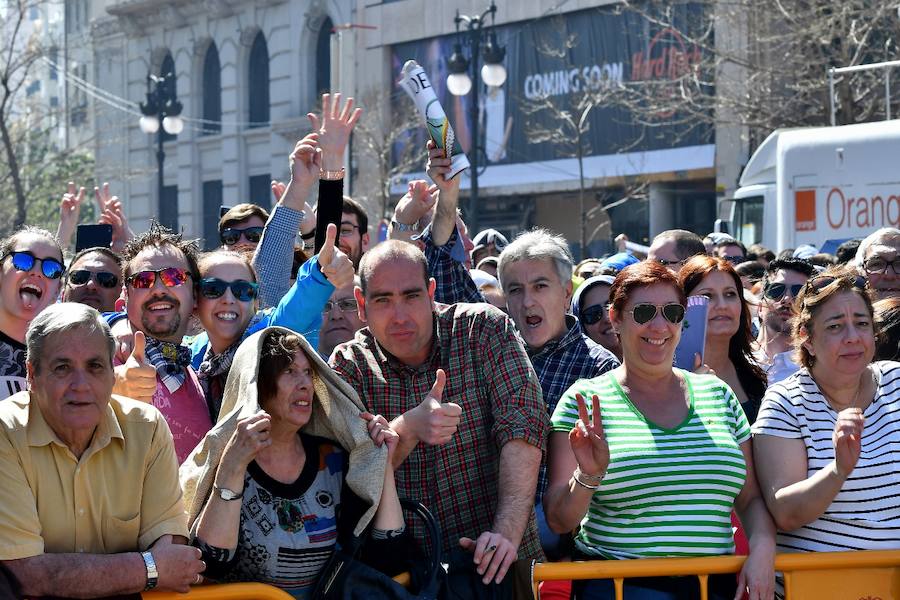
xmin=27 ymin=328 xmax=115 ymax=443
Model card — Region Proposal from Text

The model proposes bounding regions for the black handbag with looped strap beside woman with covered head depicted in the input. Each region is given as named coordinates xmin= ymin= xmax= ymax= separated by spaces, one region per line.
xmin=311 ymin=499 xmax=444 ymax=600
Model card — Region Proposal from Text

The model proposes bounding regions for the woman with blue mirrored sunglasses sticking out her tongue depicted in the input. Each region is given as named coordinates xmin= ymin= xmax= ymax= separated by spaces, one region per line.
xmin=0 ymin=225 xmax=65 ymax=400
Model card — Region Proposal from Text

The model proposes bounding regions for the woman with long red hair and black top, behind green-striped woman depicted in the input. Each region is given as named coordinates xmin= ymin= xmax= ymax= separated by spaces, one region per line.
xmin=678 ymin=256 xmax=766 ymax=425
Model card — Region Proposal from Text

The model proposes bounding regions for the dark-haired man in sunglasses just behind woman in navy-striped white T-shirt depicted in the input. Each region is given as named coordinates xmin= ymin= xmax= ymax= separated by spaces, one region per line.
xmin=755 ymin=259 xmax=816 ymax=385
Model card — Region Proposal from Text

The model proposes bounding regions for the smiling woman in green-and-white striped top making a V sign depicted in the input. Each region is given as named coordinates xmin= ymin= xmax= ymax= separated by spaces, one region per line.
xmin=544 ymin=261 xmax=775 ymax=600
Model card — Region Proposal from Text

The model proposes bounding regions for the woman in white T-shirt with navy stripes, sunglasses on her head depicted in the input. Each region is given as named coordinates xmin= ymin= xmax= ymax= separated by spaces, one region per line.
xmin=753 ymin=268 xmax=900 ymax=552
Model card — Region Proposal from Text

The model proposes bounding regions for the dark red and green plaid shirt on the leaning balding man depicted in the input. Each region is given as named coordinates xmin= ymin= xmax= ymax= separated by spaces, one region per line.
xmin=331 ymin=304 xmax=549 ymax=558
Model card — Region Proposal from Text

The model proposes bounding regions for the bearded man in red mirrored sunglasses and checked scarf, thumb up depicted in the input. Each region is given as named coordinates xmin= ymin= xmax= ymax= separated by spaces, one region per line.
xmin=114 ymin=222 xmax=212 ymax=463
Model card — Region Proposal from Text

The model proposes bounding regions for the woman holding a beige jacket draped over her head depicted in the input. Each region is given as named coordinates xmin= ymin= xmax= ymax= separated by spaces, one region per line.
xmin=180 ymin=327 xmax=410 ymax=598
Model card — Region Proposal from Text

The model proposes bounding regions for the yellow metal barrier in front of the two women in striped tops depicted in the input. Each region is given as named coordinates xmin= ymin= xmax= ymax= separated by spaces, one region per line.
xmin=532 ymin=550 xmax=900 ymax=600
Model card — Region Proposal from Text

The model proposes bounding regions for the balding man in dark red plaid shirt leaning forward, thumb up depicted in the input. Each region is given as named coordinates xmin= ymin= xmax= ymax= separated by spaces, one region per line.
xmin=331 ymin=240 xmax=549 ymax=583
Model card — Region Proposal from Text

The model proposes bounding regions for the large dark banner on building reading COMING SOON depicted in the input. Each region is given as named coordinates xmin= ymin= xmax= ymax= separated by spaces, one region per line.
xmin=392 ymin=3 xmax=714 ymax=186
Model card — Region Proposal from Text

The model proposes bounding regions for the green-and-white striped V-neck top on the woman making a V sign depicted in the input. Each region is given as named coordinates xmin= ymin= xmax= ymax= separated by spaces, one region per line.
xmin=551 ymin=370 xmax=750 ymax=559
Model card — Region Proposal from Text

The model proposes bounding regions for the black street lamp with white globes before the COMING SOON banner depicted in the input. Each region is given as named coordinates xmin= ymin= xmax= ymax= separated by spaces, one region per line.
xmin=447 ymin=0 xmax=506 ymax=232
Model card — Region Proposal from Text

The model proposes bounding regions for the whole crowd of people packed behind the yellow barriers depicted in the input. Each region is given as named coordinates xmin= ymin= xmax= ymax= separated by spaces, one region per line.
xmin=0 ymin=95 xmax=900 ymax=600
